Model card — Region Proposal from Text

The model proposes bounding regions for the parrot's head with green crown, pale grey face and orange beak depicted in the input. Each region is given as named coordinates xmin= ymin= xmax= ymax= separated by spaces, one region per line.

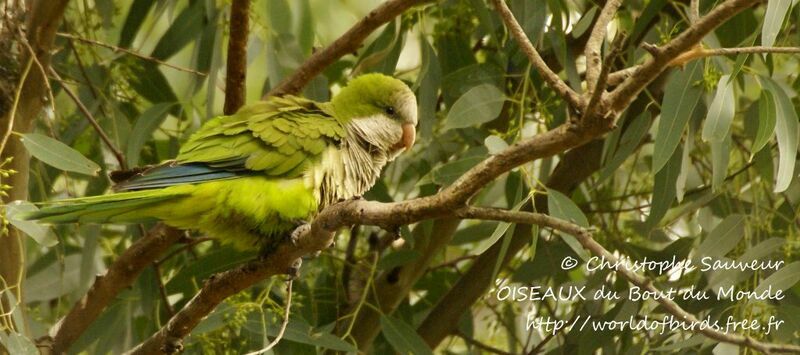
xmin=331 ymin=74 xmax=417 ymax=157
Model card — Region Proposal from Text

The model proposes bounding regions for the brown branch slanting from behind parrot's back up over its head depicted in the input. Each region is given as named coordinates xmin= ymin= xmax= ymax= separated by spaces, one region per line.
xmin=264 ymin=0 xmax=434 ymax=97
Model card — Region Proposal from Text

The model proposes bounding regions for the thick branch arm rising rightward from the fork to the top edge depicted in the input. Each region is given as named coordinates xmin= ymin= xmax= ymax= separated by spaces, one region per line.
xmin=608 ymin=0 xmax=759 ymax=112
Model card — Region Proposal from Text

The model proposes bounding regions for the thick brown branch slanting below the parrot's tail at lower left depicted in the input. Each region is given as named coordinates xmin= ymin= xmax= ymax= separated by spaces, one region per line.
xmin=49 ymin=224 xmax=183 ymax=354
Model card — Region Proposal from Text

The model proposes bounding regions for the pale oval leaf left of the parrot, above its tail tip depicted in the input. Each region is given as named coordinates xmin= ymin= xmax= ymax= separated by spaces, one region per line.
xmin=21 ymin=133 xmax=100 ymax=176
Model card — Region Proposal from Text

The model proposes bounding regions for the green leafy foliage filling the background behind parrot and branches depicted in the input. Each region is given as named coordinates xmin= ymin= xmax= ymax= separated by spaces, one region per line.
xmin=4 ymin=0 xmax=800 ymax=354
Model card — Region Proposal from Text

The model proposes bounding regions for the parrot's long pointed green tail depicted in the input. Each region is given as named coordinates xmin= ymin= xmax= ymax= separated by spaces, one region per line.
xmin=19 ymin=189 xmax=188 ymax=223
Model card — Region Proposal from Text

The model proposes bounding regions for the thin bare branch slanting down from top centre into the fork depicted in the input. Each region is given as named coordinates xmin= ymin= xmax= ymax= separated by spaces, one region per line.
xmin=492 ymin=0 xmax=584 ymax=109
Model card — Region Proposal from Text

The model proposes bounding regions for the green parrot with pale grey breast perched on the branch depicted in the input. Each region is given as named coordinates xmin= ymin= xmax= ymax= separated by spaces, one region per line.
xmin=25 ymin=74 xmax=417 ymax=252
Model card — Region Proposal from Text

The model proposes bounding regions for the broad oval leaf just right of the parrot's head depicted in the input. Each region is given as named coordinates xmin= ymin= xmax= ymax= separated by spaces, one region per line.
xmin=444 ymin=84 xmax=506 ymax=130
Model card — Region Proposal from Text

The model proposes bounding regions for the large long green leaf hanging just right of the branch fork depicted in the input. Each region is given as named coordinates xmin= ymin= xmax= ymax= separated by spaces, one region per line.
xmin=653 ymin=60 xmax=703 ymax=174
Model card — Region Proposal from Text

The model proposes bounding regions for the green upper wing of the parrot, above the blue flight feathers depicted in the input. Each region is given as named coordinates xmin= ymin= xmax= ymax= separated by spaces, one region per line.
xmin=176 ymin=96 xmax=345 ymax=178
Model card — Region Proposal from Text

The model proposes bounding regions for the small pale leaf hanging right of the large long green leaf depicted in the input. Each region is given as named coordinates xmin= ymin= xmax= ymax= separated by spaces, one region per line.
xmin=703 ymin=75 xmax=736 ymax=142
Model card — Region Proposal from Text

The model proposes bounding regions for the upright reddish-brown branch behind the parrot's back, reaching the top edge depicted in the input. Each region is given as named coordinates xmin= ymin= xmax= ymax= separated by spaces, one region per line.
xmin=223 ymin=0 xmax=250 ymax=115
